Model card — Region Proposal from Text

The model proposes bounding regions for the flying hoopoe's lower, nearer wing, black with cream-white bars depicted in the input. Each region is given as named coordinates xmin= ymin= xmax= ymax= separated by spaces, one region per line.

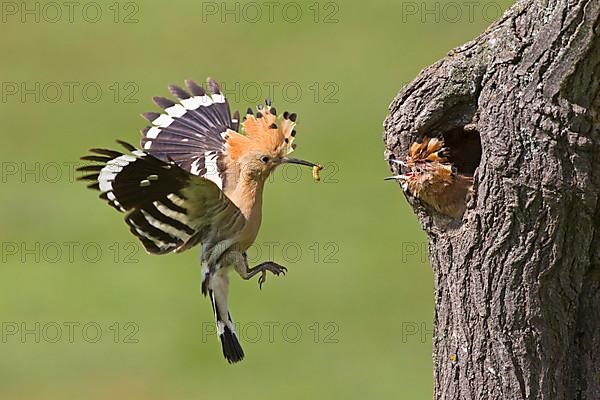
xmin=79 ymin=142 xmax=245 ymax=254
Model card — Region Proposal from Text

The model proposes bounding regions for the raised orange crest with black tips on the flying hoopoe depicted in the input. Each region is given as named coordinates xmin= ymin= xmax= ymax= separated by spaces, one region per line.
xmin=225 ymin=99 xmax=296 ymax=160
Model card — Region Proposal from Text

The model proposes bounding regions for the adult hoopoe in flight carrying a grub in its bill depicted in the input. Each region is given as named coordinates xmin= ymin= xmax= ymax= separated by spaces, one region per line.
xmin=79 ymin=78 xmax=321 ymax=363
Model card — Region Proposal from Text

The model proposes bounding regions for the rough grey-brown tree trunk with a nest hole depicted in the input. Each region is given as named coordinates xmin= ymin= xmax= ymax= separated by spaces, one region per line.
xmin=384 ymin=0 xmax=600 ymax=400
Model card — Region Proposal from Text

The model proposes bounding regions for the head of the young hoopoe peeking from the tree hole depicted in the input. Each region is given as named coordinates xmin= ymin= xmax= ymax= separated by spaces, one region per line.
xmin=386 ymin=137 xmax=456 ymax=197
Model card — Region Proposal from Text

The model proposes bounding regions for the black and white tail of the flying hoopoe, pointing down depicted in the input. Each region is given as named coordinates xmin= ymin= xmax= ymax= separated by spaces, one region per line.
xmin=202 ymin=269 xmax=244 ymax=364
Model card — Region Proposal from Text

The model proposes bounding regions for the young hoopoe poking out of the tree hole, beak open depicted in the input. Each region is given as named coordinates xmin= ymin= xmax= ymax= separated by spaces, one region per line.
xmin=386 ymin=136 xmax=473 ymax=218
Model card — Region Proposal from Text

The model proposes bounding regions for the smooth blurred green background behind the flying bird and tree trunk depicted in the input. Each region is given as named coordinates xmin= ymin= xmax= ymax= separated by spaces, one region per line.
xmin=0 ymin=0 xmax=510 ymax=400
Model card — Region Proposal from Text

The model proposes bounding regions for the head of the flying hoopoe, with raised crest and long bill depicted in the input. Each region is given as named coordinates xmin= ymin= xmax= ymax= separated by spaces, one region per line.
xmin=225 ymin=100 xmax=321 ymax=180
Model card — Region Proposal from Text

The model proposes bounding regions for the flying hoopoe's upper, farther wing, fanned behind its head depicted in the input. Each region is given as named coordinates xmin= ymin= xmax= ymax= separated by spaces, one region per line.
xmin=141 ymin=78 xmax=239 ymax=189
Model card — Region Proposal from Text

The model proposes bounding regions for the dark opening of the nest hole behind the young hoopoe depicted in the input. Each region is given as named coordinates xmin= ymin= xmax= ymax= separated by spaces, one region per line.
xmin=442 ymin=124 xmax=481 ymax=176
